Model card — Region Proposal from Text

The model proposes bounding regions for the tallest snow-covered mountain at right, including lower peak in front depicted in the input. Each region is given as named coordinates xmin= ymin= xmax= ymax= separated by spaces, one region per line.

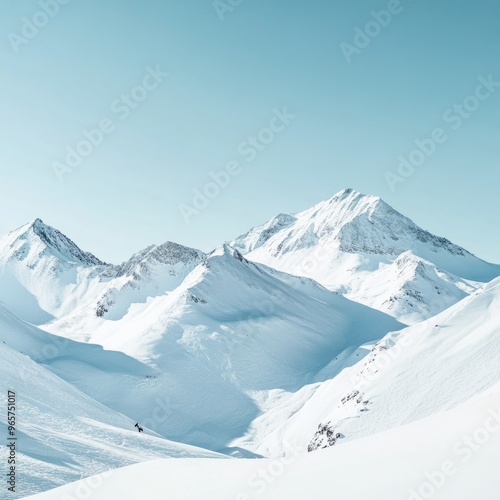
xmin=230 ymin=189 xmax=500 ymax=323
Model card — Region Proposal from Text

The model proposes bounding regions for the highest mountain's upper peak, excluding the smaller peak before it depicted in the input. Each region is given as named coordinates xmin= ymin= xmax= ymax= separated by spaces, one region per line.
xmin=231 ymin=188 xmax=500 ymax=286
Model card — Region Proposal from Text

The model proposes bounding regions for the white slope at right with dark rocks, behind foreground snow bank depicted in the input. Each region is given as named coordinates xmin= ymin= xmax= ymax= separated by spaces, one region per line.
xmin=245 ymin=279 xmax=500 ymax=458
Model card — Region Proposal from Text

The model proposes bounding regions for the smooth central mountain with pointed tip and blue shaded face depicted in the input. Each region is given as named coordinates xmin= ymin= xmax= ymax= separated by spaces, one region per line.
xmin=41 ymin=245 xmax=403 ymax=453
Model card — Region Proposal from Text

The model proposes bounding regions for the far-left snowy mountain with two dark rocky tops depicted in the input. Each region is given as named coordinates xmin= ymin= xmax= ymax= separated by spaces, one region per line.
xmin=0 ymin=219 xmax=204 ymax=325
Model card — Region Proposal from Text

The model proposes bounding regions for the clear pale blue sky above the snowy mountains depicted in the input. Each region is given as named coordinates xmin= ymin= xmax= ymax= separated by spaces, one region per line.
xmin=0 ymin=0 xmax=500 ymax=263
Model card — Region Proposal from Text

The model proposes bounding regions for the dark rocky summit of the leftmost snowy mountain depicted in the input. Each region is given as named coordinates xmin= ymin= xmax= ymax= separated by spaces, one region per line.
xmin=10 ymin=218 xmax=106 ymax=266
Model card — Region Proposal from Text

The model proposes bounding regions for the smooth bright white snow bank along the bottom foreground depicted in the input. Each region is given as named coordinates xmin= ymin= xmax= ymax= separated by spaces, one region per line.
xmin=26 ymin=385 xmax=500 ymax=500
